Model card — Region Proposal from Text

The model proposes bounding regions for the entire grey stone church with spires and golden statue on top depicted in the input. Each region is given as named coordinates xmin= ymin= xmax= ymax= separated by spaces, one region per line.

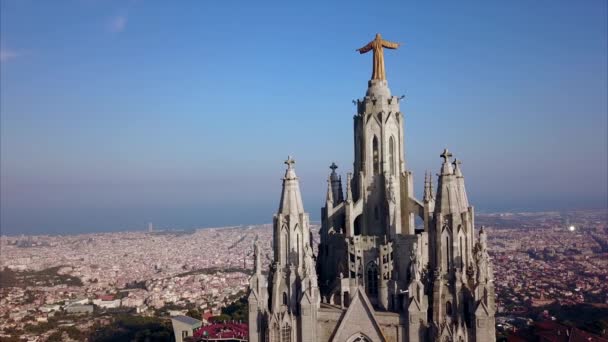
xmin=249 ymin=35 xmax=495 ymax=342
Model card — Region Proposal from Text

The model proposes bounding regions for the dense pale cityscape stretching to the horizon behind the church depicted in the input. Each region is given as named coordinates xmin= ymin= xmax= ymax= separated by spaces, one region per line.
xmin=0 ymin=210 xmax=608 ymax=341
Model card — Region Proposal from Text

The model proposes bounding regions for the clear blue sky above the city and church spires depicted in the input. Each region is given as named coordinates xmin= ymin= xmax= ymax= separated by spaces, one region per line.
xmin=0 ymin=0 xmax=608 ymax=234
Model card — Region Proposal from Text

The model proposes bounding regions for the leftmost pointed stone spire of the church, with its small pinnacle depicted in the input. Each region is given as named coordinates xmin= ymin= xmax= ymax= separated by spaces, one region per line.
xmin=249 ymin=157 xmax=320 ymax=342
